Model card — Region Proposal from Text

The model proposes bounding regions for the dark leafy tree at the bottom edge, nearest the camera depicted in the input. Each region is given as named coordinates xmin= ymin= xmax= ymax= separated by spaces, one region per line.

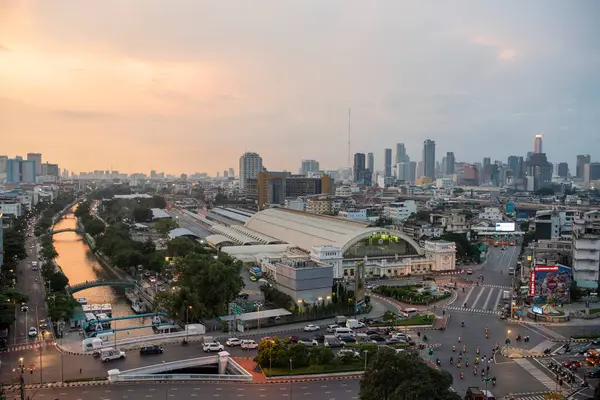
xmin=360 ymin=349 xmax=460 ymax=400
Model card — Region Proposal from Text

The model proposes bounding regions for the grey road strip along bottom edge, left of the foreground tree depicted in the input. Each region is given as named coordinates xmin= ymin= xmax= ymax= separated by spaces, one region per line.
xmin=7 ymin=380 xmax=359 ymax=400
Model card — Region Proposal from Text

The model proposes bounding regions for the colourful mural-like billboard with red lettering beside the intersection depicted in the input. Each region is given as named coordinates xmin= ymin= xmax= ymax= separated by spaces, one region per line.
xmin=529 ymin=264 xmax=573 ymax=303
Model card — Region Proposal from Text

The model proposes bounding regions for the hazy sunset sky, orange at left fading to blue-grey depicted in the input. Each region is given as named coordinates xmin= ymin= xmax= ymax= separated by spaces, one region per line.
xmin=0 ymin=0 xmax=600 ymax=174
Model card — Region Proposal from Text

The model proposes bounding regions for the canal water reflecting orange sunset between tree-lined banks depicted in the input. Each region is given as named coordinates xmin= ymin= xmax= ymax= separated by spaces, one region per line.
xmin=54 ymin=214 xmax=153 ymax=338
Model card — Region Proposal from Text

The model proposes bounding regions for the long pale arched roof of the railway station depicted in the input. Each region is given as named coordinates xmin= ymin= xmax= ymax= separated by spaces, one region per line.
xmin=244 ymin=208 xmax=423 ymax=255
